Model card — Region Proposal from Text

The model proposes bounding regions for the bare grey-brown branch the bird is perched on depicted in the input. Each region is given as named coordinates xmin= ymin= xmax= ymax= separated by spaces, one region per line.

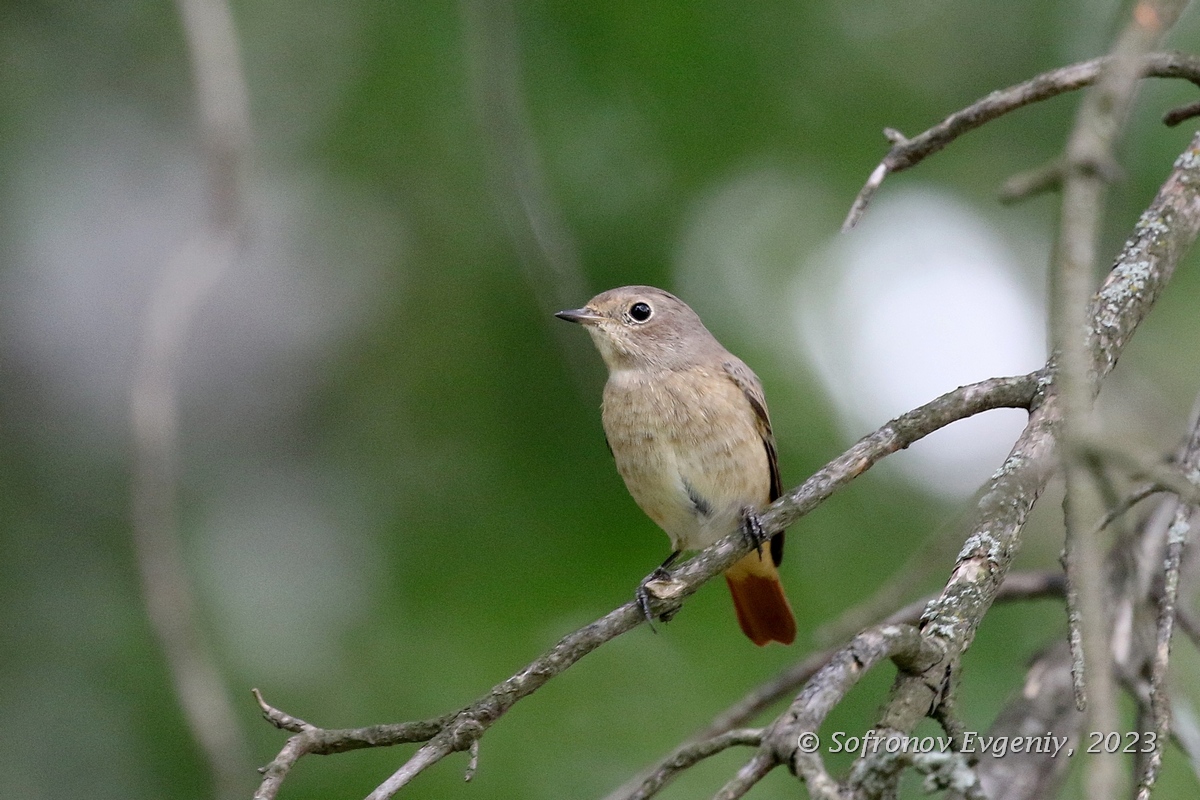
xmin=254 ymin=373 xmax=1040 ymax=800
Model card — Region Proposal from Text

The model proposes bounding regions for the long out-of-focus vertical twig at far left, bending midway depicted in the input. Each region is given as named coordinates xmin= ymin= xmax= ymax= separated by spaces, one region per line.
xmin=130 ymin=0 xmax=250 ymax=798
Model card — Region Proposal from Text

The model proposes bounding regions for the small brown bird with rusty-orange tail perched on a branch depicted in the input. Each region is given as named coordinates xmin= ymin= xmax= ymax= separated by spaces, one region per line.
xmin=556 ymin=287 xmax=796 ymax=645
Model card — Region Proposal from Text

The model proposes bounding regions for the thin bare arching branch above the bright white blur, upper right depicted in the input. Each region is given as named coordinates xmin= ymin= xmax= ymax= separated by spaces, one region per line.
xmin=841 ymin=53 xmax=1200 ymax=230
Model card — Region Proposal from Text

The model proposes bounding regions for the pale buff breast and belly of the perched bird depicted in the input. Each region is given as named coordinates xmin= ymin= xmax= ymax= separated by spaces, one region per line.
xmin=602 ymin=369 xmax=770 ymax=549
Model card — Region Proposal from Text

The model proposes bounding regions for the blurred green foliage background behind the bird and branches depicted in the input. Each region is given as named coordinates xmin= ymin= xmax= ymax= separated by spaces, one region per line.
xmin=0 ymin=0 xmax=1200 ymax=800
